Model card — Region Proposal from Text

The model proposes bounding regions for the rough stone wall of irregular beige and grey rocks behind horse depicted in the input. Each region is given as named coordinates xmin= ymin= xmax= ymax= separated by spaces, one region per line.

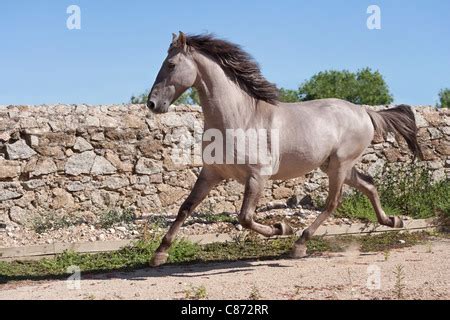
xmin=0 ymin=105 xmax=450 ymax=224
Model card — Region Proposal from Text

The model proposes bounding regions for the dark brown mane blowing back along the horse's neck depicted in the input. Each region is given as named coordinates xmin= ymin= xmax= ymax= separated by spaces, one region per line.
xmin=186 ymin=34 xmax=278 ymax=104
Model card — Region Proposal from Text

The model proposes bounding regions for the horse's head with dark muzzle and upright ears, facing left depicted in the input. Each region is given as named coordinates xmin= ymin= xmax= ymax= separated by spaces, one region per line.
xmin=147 ymin=31 xmax=197 ymax=113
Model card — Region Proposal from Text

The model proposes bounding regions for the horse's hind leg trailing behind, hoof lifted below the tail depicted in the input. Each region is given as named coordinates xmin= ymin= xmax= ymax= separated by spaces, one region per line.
xmin=345 ymin=168 xmax=403 ymax=228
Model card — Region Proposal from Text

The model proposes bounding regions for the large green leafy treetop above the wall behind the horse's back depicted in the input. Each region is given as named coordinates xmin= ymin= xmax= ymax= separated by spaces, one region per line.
xmin=298 ymin=68 xmax=393 ymax=105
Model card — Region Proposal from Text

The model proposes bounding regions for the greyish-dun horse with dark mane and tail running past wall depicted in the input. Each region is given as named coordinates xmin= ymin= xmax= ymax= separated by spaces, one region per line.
xmin=147 ymin=31 xmax=422 ymax=266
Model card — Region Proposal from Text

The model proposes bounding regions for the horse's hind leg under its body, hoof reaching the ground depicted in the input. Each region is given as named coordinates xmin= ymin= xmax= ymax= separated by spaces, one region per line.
xmin=291 ymin=159 xmax=352 ymax=258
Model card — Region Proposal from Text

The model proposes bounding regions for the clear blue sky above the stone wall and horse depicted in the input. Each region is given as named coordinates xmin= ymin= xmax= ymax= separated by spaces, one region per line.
xmin=0 ymin=0 xmax=450 ymax=105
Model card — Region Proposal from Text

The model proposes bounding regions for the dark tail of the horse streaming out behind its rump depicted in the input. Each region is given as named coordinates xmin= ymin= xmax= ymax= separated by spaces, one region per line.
xmin=367 ymin=104 xmax=423 ymax=160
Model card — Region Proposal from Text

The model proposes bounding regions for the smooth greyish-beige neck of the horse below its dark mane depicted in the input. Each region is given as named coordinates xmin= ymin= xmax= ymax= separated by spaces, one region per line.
xmin=195 ymin=54 xmax=257 ymax=130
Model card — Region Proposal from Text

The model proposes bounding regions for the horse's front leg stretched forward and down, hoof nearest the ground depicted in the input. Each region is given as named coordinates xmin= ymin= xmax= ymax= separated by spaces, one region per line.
xmin=150 ymin=167 xmax=222 ymax=267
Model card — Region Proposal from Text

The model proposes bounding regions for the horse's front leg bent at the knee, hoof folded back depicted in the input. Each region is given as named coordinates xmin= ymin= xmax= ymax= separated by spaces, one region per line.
xmin=238 ymin=176 xmax=294 ymax=237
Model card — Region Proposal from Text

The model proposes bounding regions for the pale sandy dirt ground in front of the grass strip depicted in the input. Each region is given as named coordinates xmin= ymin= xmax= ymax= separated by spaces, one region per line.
xmin=0 ymin=239 xmax=450 ymax=299
